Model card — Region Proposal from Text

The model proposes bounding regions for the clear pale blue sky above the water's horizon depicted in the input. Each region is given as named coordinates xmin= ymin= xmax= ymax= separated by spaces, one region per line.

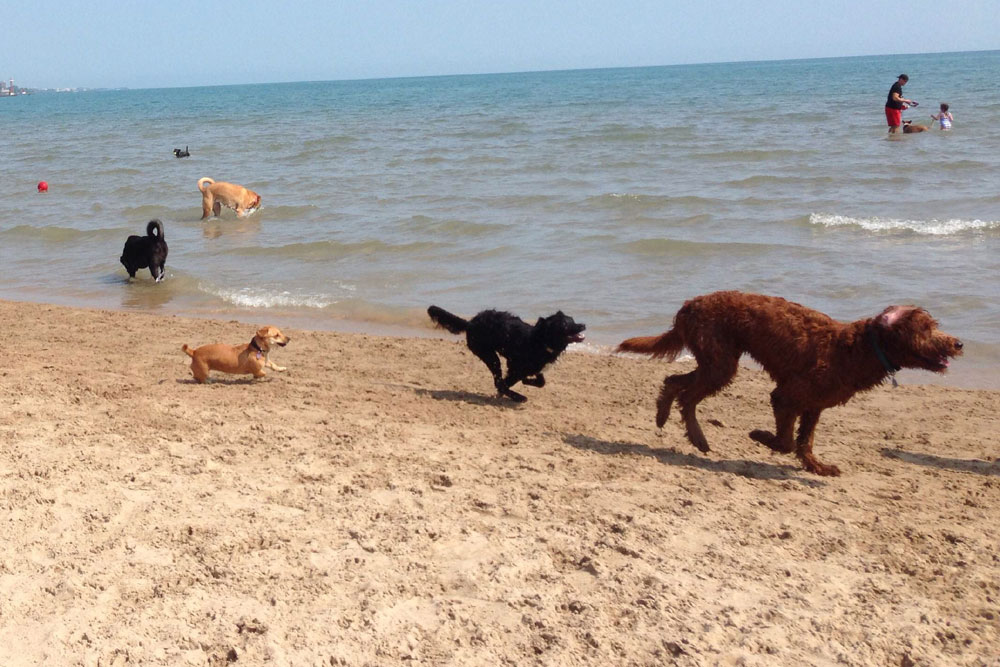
xmin=0 ymin=0 xmax=1000 ymax=88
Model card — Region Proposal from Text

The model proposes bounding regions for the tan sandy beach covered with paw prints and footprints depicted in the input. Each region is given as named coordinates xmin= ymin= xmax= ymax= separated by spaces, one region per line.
xmin=0 ymin=303 xmax=1000 ymax=666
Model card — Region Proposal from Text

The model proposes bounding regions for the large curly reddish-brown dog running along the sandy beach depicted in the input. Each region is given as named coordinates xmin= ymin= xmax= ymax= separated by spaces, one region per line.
xmin=618 ymin=292 xmax=962 ymax=475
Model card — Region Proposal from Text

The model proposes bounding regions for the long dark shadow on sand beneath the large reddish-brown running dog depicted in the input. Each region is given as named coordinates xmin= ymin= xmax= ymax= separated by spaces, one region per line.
xmin=563 ymin=434 xmax=826 ymax=488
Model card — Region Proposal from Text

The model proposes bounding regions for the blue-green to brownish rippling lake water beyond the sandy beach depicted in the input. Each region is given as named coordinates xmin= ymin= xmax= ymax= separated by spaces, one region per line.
xmin=0 ymin=52 xmax=1000 ymax=387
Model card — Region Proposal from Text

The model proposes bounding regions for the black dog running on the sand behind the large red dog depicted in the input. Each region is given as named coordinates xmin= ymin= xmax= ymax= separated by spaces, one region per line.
xmin=427 ymin=306 xmax=587 ymax=403
